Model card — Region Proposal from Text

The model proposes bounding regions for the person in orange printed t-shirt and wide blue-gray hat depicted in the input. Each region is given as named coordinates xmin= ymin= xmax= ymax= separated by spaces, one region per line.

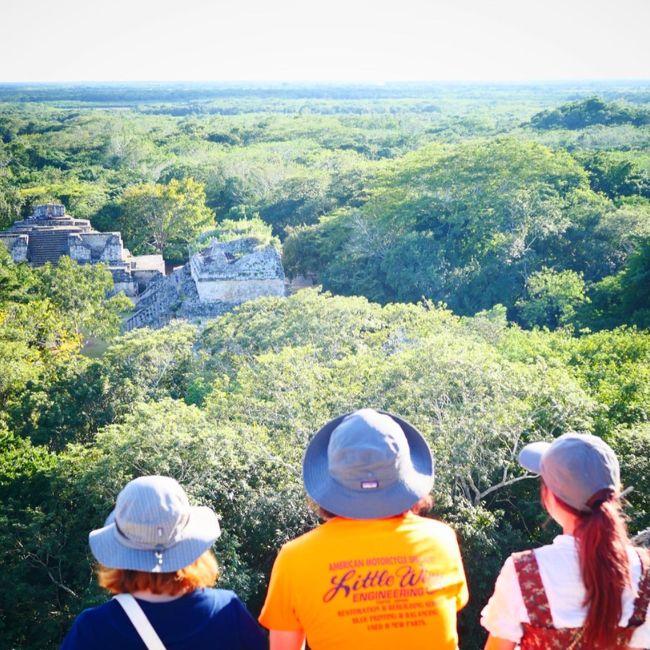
xmin=259 ymin=409 xmax=468 ymax=650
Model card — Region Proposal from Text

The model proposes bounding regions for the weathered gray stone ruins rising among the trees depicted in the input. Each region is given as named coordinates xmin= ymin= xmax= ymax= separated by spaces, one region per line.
xmin=0 ymin=204 xmax=286 ymax=330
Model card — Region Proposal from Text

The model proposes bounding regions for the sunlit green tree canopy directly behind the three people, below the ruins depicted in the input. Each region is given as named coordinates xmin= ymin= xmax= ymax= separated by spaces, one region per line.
xmin=0 ymin=284 xmax=650 ymax=648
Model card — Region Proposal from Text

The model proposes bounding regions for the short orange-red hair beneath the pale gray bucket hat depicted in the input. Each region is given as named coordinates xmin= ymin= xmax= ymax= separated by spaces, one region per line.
xmin=97 ymin=549 xmax=219 ymax=596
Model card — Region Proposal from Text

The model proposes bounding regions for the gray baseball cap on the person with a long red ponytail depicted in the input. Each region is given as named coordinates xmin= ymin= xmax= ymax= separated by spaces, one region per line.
xmin=519 ymin=433 xmax=620 ymax=512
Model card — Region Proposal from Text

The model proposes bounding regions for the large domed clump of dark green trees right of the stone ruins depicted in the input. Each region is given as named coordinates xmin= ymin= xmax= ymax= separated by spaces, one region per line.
xmin=285 ymin=139 xmax=650 ymax=325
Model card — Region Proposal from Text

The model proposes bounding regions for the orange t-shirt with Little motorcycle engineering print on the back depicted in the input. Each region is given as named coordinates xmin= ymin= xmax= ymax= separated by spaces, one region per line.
xmin=259 ymin=513 xmax=468 ymax=650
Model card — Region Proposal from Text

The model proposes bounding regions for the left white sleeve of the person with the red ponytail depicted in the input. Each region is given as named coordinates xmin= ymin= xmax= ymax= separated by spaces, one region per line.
xmin=481 ymin=557 xmax=529 ymax=643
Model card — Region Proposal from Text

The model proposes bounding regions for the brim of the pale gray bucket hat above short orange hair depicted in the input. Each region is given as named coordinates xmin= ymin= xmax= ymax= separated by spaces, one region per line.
xmin=88 ymin=506 xmax=221 ymax=573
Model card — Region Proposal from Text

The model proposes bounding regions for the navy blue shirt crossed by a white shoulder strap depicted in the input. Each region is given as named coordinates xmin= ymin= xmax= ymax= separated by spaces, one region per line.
xmin=61 ymin=589 xmax=268 ymax=650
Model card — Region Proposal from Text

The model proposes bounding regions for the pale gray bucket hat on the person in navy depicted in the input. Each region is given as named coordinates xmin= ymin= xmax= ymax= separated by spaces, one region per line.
xmin=88 ymin=476 xmax=221 ymax=573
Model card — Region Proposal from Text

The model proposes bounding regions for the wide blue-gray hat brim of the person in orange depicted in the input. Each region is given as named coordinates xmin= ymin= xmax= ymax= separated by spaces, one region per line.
xmin=302 ymin=411 xmax=434 ymax=519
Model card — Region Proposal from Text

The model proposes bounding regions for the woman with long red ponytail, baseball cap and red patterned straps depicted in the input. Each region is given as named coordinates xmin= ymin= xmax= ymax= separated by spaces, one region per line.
xmin=481 ymin=434 xmax=650 ymax=650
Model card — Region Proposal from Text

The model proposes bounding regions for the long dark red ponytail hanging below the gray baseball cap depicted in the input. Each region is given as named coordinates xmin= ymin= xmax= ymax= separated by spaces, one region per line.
xmin=553 ymin=490 xmax=630 ymax=649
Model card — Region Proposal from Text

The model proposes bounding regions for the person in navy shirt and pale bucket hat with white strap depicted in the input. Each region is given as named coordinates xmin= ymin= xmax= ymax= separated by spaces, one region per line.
xmin=61 ymin=476 xmax=268 ymax=650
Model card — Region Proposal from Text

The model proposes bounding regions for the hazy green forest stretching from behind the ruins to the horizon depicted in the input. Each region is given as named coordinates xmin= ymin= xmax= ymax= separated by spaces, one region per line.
xmin=0 ymin=90 xmax=650 ymax=322
